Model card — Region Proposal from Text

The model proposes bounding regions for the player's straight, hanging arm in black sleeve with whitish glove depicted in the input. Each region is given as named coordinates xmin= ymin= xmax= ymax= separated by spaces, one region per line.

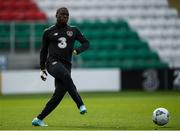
xmin=40 ymin=30 xmax=49 ymax=81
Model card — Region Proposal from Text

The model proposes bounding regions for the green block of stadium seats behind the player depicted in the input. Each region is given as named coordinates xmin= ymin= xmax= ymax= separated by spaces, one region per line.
xmin=0 ymin=20 xmax=168 ymax=69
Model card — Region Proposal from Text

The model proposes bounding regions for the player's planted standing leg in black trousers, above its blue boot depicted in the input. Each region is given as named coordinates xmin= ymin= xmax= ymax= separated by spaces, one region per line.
xmin=37 ymin=79 xmax=66 ymax=120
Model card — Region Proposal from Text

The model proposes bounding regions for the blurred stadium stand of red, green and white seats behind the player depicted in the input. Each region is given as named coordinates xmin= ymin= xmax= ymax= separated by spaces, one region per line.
xmin=0 ymin=0 xmax=180 ymax=69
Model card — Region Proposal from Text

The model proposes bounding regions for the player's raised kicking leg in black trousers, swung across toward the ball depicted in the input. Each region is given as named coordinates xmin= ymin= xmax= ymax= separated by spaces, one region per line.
xmin=48 ymin=62 xmax=87 ymax=114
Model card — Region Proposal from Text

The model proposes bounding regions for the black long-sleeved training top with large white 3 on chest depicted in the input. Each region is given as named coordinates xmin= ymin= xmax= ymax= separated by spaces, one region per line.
xmin=40 ymin=24 xmax=89 ymax=70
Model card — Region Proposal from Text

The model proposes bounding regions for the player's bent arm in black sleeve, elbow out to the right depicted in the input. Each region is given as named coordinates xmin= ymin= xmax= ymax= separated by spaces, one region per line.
xmin=73 ymin=28 xmax=90 ymax=54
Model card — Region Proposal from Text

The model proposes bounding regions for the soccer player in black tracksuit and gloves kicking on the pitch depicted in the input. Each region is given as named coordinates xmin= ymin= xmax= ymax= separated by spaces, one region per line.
xmin=32 ymin=7 xmax=89 ymax=126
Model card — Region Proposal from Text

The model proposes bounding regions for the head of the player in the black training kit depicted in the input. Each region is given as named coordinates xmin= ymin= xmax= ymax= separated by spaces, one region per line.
xmin=56 ymin=7 xmax=69 ymax=25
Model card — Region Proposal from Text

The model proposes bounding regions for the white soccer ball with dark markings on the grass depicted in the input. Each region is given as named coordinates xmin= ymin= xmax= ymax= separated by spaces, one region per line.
xmin=152 ymin=107 xmax=169 ymax=126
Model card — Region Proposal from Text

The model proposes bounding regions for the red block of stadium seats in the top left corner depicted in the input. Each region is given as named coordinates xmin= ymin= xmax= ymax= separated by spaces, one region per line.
xmin=0 ymin=0 xmax=46 ymax=21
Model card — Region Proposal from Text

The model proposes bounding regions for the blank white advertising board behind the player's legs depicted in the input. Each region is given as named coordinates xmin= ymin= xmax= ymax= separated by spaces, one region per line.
xmin=1 ymin=69 xmax=121 ymax=94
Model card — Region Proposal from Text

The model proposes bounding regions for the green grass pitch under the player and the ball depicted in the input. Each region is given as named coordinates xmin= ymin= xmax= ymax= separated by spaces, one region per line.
xmin=0 ymin=91 xmax=180 ymax=130
